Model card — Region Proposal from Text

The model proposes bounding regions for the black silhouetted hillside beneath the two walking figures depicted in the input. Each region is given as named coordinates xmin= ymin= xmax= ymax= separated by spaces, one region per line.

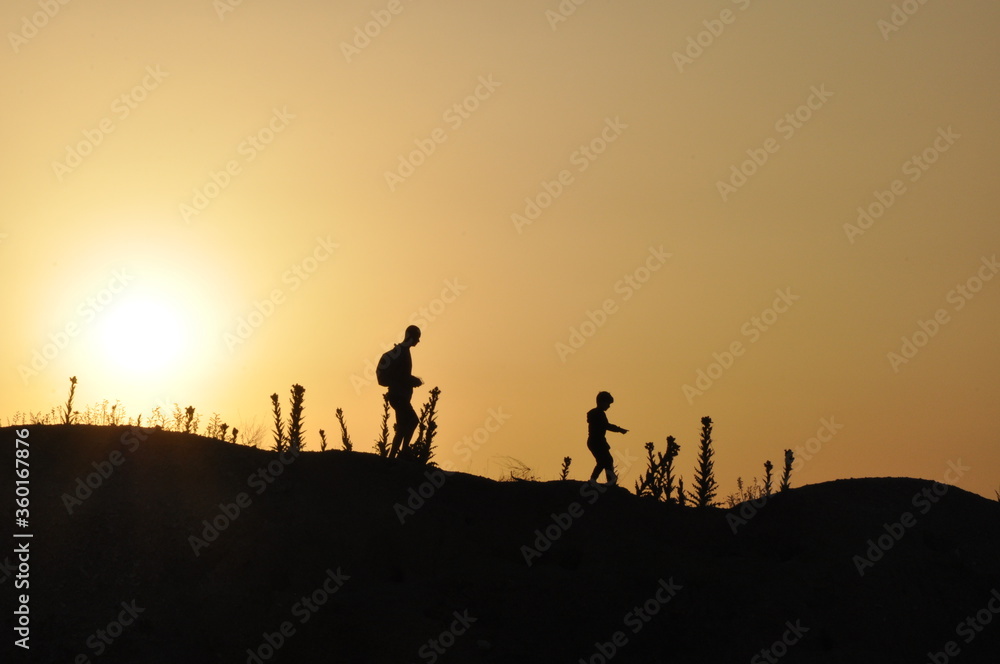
xmin=0 ymin=426 xmax=1000 ymax=664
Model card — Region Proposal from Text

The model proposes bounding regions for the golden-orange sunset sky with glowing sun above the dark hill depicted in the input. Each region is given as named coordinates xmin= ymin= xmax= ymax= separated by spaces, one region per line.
xmin=0 ymin=0 xmax=1000 ymax=497
